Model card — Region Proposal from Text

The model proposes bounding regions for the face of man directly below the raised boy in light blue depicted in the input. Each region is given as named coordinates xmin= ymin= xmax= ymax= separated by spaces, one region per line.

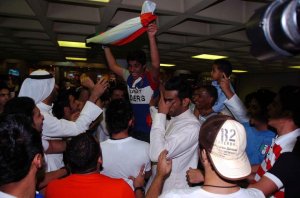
xmin=193 ymin=88 xmax=213 ymax=109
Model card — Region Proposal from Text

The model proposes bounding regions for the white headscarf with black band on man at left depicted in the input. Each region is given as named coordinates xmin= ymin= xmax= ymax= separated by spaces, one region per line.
xmin=19 ymin=70 xmax=55 ymax=104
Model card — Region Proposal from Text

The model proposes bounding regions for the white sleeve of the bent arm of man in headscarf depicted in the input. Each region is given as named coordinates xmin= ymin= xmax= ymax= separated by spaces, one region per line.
xmin=42 ymin=101 xmax=102 ymax=137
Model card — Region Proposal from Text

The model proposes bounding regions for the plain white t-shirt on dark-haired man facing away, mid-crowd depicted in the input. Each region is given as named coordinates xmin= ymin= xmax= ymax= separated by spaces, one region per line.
xmin=100 ymin=137 xmax=151 ymax=189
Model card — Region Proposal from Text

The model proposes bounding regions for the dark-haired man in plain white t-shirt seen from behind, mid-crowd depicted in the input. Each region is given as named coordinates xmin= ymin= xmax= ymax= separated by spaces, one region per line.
xmin=101 ymin=99 xmax=151 ymax=189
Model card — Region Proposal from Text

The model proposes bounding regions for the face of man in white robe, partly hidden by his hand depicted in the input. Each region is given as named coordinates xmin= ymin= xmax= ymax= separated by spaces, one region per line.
xmin=164 ymin=90 xmax=186 ymax=117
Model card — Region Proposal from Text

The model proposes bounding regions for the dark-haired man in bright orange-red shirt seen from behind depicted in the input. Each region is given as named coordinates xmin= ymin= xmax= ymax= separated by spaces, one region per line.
xmin=46 ymin=133 xmax=134 ymax=198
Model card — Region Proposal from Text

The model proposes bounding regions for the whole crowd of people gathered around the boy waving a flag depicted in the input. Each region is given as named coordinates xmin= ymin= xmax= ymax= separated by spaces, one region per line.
xmin=0 ymin=24 xmax=300 ymax=198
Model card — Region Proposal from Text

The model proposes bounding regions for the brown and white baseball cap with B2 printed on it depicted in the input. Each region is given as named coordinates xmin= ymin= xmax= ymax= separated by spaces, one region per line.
xmin=199 ymin=115 xmax=251 ymax=180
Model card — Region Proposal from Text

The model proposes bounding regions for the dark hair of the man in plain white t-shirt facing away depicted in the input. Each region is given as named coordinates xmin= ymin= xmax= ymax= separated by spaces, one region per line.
xmin=105 ymin=99 xmax=133 ymax=135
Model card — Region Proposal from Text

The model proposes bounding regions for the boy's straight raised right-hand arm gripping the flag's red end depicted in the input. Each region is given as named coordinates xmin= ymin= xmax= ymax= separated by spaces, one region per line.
xmin=147 ymin=23 xmax=160 ymax=81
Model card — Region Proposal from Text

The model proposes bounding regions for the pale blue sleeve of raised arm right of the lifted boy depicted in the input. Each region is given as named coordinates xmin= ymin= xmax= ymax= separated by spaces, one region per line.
xmin=224 ymin=94 xmax=249 ymax=123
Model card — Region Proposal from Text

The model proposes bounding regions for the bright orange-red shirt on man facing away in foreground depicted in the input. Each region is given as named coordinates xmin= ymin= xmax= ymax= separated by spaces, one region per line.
xmin=45 ymin=173 xmax=134 ymax=198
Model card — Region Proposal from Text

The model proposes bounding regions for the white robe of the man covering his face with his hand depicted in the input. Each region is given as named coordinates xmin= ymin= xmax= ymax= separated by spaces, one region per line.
xmin=147 ymin=109 xmax=200 ymax=192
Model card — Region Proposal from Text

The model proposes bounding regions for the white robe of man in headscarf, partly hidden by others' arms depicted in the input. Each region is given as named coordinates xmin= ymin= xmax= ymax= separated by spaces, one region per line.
xmin=37 ymin=101 xmax=102 ymax=172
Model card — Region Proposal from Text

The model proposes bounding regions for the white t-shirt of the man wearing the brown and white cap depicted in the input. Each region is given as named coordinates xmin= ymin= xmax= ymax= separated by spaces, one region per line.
xmin=159 ymin=187 xmax=265 ymax=198
